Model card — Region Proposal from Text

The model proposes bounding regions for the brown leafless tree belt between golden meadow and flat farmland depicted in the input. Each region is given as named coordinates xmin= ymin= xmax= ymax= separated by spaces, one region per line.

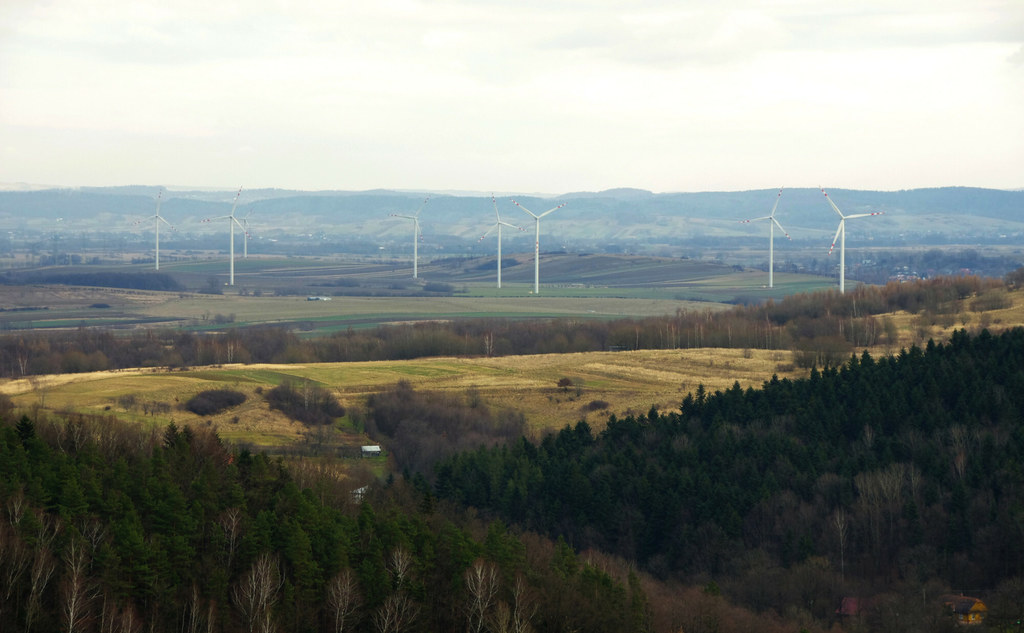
xmin=0 ymin=270 xmax=1010 ymax=377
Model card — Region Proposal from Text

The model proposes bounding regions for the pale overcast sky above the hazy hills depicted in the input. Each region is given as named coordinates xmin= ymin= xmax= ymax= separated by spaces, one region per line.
xmin=0 ymin=0 xmax=1024 ymax=194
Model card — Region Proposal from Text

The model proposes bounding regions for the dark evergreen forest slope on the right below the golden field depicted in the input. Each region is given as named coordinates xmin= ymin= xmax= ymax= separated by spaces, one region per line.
xmin=436 ymin=329 xmax=1024 ymax=630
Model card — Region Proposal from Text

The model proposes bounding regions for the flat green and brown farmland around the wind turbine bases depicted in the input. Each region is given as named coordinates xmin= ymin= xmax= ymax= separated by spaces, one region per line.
xmin=0 ymin=250 xmax=830 ymax=336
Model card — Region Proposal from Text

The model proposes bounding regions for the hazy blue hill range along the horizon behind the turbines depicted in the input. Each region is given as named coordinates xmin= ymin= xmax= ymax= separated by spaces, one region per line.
xmin=0 ymin=186 xmax=1024 ymax=250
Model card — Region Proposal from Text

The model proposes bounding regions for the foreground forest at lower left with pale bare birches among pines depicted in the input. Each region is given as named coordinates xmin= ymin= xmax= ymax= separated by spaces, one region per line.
xmin=0 ymin=399 xmax=663 ymax=633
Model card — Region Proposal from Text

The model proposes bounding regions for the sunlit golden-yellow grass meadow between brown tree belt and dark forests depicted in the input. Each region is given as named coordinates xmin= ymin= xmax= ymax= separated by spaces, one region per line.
xmin=8 ymin=291 xmax=1024 ymax=446
